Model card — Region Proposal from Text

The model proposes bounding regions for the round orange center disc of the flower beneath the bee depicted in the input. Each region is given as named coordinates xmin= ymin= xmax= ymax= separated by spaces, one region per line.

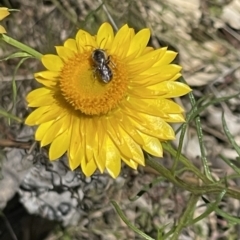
xmin=60 ymin=51 xmax=128 ymax=115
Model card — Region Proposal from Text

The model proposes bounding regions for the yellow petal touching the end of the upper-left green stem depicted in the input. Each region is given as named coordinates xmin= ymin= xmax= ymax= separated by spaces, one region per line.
xmin=41 ymin=54 xmax=64 ymax=72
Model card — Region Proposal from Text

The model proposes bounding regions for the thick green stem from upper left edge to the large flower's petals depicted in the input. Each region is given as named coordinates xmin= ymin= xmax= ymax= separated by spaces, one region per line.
xmin=0 ymin=34 xmax=42 ymax=59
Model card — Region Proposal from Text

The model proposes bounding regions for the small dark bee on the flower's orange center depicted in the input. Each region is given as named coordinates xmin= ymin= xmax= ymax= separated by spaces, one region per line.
xmin=92 ymin=49 xmax=113 ymax=83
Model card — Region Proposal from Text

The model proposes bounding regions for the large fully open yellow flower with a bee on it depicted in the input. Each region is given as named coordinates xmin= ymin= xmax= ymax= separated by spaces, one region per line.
xmin=26 ymin=23 xmax=191 ymax=178
